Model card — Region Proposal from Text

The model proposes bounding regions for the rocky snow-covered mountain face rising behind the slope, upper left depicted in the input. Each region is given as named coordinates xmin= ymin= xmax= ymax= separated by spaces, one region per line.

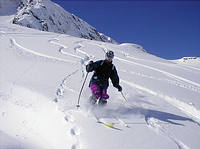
xmin=13 ymin=0 xmax=117 ymax=43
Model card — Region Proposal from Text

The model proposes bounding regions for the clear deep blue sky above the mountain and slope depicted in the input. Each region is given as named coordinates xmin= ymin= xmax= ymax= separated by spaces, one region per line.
xmin=52 ymin=0 xmax=200 ymax=59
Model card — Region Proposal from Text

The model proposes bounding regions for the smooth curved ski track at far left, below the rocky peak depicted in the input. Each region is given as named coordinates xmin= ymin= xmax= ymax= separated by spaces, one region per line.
xmin=10 ymin=38 xmax=75 ymax=63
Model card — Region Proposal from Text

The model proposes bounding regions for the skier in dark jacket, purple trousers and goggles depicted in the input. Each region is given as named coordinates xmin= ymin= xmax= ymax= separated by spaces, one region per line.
xmin=86 ymin=51 xmax=122 ymax=105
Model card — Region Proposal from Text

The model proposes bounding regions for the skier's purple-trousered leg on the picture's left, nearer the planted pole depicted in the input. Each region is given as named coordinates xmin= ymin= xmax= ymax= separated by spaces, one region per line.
xmin=90 ymin=83 xmax=101 ymax=104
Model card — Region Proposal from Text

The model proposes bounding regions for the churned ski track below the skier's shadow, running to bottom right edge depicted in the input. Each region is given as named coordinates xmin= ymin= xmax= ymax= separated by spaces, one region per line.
xmin=145 ymin=117 xmax=190 ymax=149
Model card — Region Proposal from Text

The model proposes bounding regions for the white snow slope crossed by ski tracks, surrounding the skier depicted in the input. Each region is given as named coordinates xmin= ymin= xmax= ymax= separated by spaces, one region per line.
xmin=0 ymin=16 xmax=200 ymax=149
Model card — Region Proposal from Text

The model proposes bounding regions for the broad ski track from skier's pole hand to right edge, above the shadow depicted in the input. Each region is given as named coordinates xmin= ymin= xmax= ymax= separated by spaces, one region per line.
xmin=121 ymin=80 xmax=200 ymax=126
